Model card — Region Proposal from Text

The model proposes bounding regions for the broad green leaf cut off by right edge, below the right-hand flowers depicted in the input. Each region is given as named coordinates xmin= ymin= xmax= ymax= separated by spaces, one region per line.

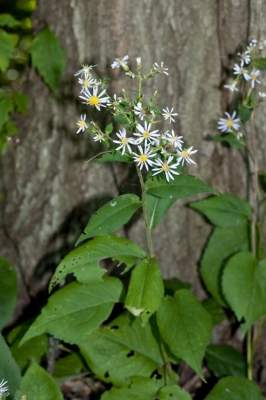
xmin=222 ymin=251 xmax=266 ymax=332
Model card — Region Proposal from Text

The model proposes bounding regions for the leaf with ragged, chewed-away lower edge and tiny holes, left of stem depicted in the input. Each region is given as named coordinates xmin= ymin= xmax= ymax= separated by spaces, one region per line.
xmin=49 ymin=235 xmax=146 ymax=291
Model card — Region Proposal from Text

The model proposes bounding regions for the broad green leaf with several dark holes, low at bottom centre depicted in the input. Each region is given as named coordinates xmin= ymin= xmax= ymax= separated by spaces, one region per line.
xmin=79 ymin=313 xmax=165 ymax=386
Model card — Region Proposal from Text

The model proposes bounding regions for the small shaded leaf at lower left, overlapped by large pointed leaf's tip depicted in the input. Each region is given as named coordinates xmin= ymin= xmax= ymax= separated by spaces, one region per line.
xmin=7 ymin=324 xmax=48 ymax=373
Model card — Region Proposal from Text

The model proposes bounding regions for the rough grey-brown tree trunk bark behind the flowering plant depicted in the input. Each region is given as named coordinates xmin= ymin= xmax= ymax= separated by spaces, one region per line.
xmin=0 ymin=0 xmax=266 ymax=318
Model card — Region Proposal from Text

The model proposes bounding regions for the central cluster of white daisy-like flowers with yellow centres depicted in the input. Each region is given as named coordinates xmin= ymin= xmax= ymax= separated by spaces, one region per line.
xmin=75 ymin=55 xmax=197 ymax=182
